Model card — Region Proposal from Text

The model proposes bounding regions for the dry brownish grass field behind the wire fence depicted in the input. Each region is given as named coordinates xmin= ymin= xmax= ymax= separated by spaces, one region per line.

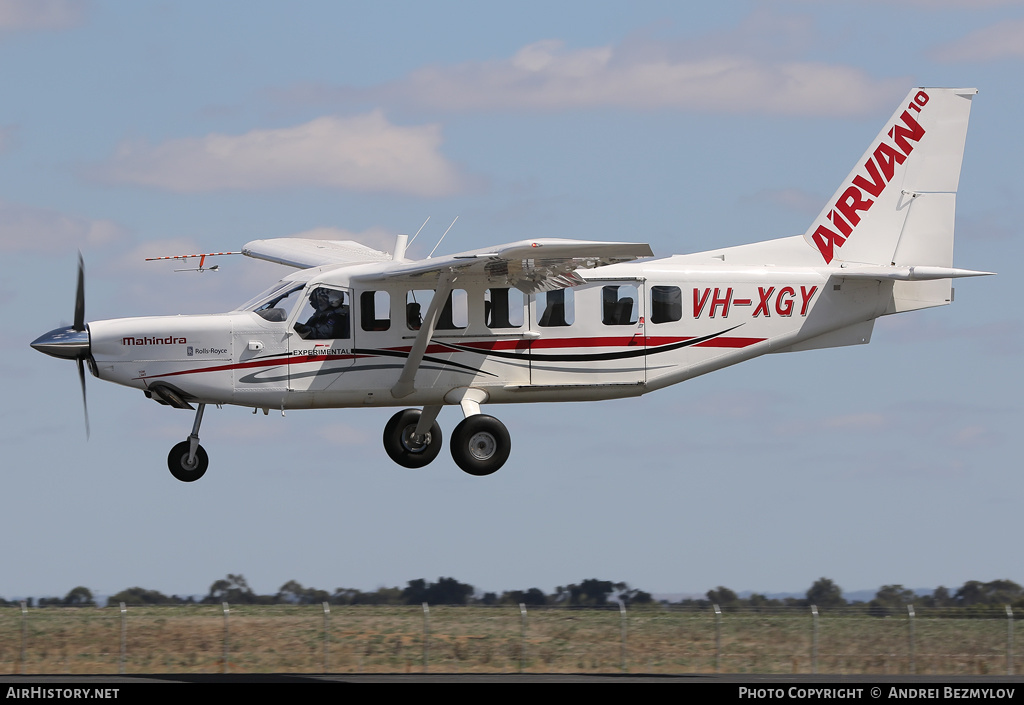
xmin=0 ymin=605 xmax=1022 ymax=674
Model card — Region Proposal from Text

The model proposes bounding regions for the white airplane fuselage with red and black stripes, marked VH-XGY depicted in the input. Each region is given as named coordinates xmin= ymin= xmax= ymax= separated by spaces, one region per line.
xmin=89 ymin=251 xmax=901 ymax=409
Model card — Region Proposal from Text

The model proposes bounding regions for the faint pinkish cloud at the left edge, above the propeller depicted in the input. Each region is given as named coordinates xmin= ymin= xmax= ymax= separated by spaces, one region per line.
xmin=0 ymin=201 xmax=125 ymax=252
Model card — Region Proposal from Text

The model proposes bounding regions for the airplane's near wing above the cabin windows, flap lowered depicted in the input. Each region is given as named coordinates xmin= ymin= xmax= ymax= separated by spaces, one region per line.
xmin=372 ymin=238 xmax=653 ymax=294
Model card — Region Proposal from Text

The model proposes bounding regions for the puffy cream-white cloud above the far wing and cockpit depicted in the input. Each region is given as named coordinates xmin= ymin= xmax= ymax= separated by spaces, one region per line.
xmin=98 ymin=111 xmax=464 ymax=197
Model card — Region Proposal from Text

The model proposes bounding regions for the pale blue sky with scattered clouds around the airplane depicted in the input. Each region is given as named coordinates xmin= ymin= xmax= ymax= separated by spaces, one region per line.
xmin=0 ymin=0 xmax=1024 ymax=598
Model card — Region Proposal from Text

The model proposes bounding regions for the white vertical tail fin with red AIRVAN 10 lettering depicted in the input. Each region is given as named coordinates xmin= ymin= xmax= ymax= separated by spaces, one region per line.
xmin=804 ymin=88 xmax=978 ymax=270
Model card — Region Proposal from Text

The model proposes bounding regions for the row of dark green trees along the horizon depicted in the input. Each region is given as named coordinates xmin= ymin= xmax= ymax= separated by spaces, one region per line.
xmin=0 ymin=574 xmax=1024 ymax=617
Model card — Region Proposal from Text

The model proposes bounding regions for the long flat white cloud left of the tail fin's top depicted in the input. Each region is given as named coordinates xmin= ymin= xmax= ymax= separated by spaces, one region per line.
xmin=299 ymin=32 xmax=908 ymax=116
